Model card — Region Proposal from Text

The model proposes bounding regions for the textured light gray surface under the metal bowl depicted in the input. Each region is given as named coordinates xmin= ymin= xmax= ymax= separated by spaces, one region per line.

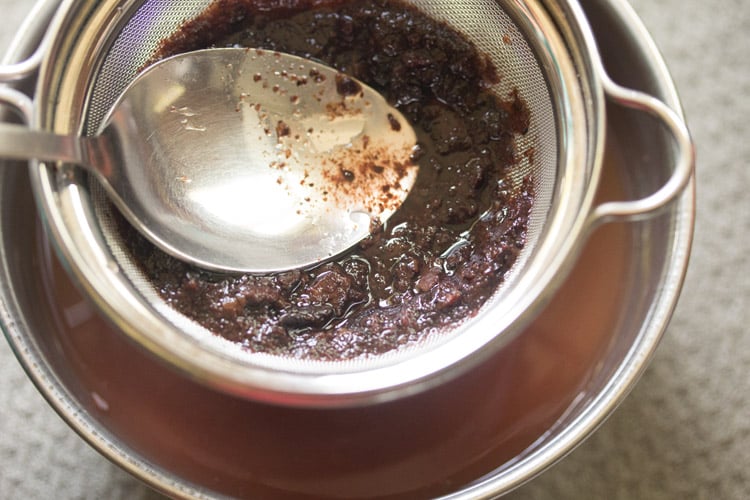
xmin=0 ymin=0 xmax=750 ymax=500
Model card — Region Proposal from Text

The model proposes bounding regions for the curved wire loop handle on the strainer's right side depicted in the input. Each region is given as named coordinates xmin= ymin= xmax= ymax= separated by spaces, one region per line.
xmin=590 ymin=75 xmax=695 ymax=225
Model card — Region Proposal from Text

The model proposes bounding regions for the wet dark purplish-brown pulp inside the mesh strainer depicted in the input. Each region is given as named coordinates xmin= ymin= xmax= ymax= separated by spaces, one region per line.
xmin=122 ymin=0 xmax=533 ymax=360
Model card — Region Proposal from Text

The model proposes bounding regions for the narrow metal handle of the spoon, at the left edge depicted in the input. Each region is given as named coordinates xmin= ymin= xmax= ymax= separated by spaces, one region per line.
xmin=0 ymin=123 xmax=88 ymax=165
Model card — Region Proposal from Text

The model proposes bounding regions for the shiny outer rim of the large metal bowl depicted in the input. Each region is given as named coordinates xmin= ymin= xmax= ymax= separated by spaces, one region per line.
xmin=0 ymin=0 xmax=695 ymax=498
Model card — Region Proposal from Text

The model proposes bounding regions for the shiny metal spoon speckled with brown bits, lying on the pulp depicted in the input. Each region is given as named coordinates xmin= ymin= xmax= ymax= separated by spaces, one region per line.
xmin=0 ymin=49 xmax=417 ymax=272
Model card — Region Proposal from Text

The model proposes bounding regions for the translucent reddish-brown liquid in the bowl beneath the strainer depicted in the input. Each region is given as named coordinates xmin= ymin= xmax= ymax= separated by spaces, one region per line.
xmin=35 ymin=147 xmax=629 ymax=498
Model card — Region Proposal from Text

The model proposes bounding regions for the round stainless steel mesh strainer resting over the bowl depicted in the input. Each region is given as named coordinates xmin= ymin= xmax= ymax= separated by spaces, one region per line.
xmin=17 ymin=0 xmax=692 ymax=406
